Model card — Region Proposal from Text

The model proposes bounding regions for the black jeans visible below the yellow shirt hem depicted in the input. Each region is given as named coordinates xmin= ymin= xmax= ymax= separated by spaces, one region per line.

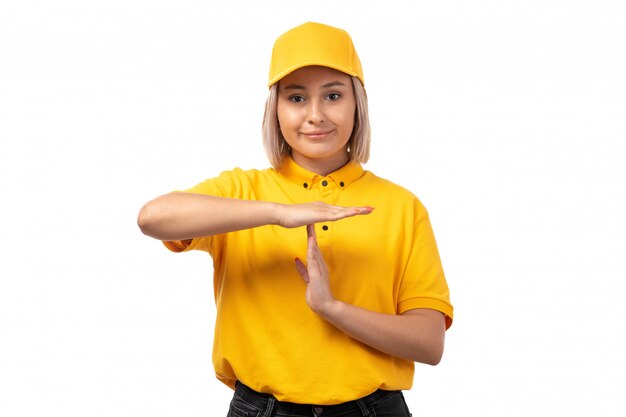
xmin=227 ymin=382 xmax=411 ymax=417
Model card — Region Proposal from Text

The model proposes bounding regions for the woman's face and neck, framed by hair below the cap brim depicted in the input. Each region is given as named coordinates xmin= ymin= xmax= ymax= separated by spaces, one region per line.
xmin=277 ymin=66 xmax=356 ymax=175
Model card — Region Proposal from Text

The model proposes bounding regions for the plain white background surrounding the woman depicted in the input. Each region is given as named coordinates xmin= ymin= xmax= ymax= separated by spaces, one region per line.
xmin=0 ymin=0 xmax=626 ymax=417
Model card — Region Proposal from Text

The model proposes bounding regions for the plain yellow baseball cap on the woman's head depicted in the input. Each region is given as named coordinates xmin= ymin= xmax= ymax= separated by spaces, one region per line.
xmin=268 ymin=22 xmax=365 ymax=86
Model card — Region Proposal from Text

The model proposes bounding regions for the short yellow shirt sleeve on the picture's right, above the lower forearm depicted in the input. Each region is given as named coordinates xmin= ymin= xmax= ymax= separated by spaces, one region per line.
xmin=398 ymin=201 xmax=453 ymax=329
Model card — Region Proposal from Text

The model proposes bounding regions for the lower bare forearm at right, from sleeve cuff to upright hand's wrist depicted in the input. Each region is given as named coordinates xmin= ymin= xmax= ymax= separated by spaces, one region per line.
xmin=318 ymin=301 xmax=445 ymax=365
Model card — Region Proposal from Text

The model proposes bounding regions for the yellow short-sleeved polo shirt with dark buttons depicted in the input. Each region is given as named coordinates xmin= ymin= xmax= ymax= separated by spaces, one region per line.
xmin=164 ymin=158 xmax=452 ymax=405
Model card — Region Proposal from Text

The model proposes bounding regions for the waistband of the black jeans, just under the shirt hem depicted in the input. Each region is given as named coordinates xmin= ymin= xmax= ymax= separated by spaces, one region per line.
xmin=235 ymin=381 xmax=400 ymax=417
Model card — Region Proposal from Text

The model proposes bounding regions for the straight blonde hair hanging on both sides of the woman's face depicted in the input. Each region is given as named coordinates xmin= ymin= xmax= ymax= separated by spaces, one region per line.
xmin=263 ymin=77 xmax=372 ymax=169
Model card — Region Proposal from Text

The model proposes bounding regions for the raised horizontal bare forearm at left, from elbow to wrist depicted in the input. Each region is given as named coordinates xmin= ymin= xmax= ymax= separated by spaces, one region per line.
xmin=137 ymin=192 xmax=276 ymax=240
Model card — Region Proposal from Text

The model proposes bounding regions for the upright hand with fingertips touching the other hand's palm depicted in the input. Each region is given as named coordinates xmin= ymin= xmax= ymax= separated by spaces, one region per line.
xmin=296 ymin=224 xmax=336 ymax=316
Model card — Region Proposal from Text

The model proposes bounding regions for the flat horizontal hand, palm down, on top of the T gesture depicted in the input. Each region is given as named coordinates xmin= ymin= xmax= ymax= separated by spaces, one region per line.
xmin=276 ymin=201 xmax=374 ymax=228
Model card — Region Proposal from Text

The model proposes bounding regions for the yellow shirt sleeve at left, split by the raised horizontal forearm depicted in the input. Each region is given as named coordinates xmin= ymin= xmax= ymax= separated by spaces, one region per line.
xmin=163 ymin=168 xmax=245 ymax=256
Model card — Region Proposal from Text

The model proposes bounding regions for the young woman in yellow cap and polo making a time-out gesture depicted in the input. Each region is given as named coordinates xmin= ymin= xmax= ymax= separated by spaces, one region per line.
xmin=138 ymin=23 xmax=452 ymax=417
